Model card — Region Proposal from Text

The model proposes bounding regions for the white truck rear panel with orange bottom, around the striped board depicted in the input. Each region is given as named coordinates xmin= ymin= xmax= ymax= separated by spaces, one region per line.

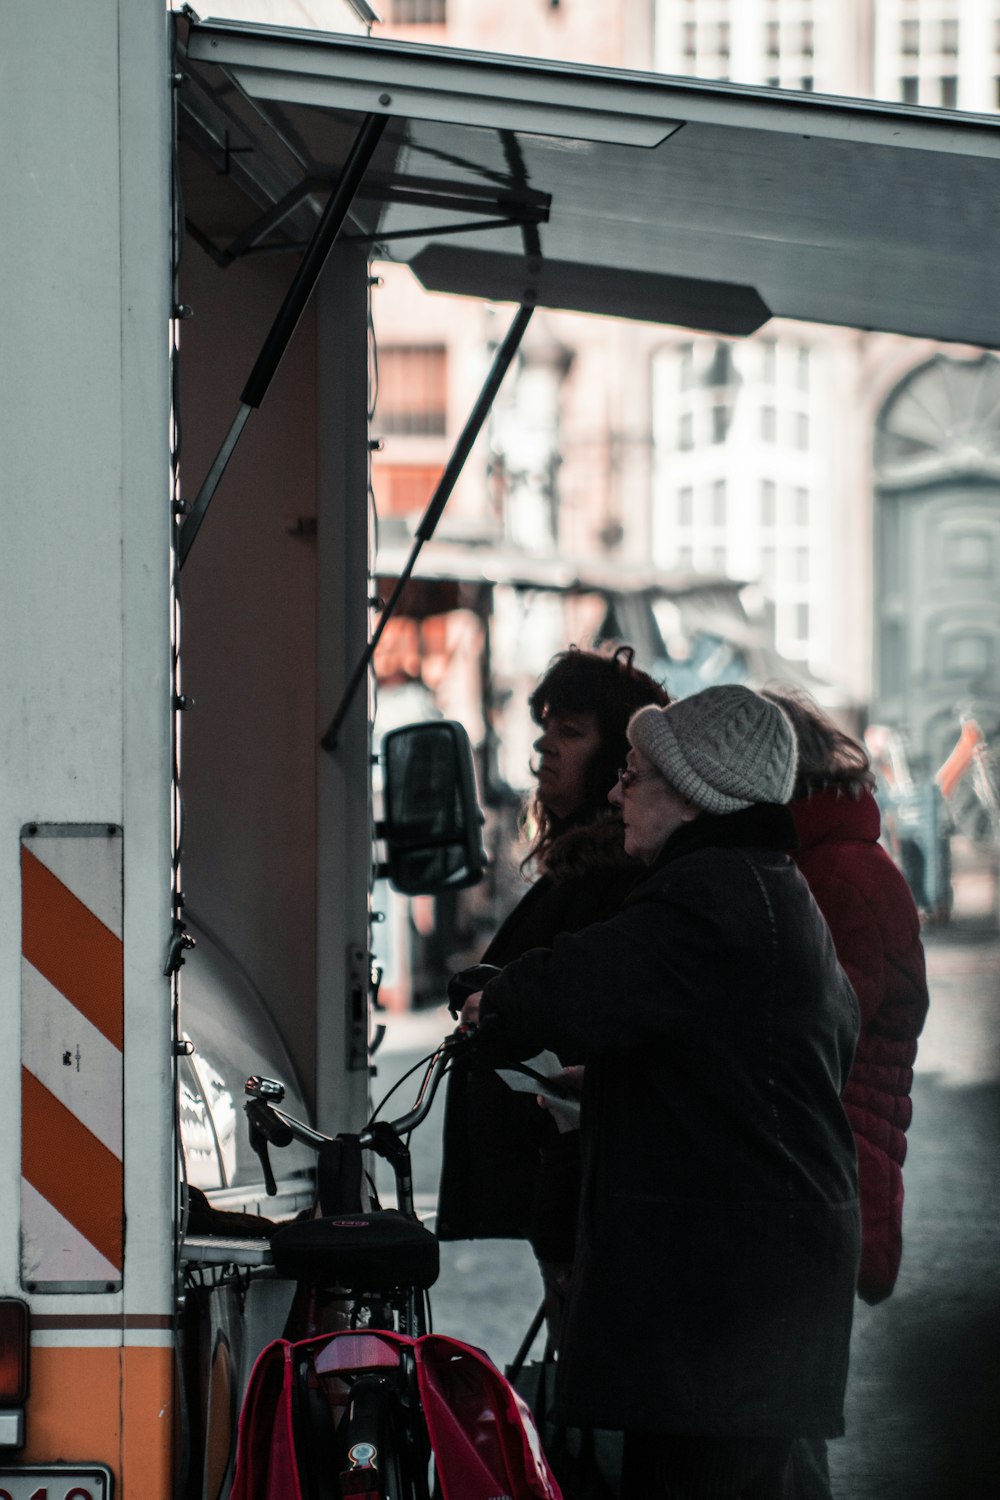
xmin=0 ymin=0 xmax=175 ymax=1497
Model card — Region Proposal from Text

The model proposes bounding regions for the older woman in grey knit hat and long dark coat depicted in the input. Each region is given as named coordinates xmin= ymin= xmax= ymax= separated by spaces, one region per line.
xmin=465 ymin=686 xmax=859 ymax=1500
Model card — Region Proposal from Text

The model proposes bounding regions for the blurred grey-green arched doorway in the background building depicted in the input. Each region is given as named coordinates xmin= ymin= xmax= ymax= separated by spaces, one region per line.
xmin=871 ymin=354 xmax=1000 ymax=798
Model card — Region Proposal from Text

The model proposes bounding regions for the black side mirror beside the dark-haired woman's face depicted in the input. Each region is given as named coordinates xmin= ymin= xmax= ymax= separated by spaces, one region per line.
xmin=378 ymin=720 xmax=486 ymax=896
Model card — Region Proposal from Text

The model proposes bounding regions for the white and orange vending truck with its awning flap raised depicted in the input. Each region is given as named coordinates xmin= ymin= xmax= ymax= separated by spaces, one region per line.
xmin=0 ymin=0 xmax=1000 ymax=1500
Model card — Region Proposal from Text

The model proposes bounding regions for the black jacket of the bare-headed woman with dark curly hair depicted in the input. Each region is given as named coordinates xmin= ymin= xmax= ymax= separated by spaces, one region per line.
xmin=436 ymin=819 xmax=642 ymax=1242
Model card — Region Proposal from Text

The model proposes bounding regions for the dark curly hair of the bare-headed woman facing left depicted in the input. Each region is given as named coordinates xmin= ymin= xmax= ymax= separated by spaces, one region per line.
xmin=525 ymin=647 xmax=670 ymax=864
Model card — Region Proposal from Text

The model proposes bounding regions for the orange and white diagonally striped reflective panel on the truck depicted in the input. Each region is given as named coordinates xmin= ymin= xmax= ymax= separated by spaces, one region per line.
xmin=21 ymin=824 xmax=124 ymax=1292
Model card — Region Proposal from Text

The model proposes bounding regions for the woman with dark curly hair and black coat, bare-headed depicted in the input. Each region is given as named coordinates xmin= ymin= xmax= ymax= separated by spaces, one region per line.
xmin=436 ymin=647 xmax=669 ymax=1326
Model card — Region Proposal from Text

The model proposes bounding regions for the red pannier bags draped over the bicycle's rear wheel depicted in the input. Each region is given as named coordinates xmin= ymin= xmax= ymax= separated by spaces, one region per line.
xmin=231 ymin=1329 xmax=562 ymax=1500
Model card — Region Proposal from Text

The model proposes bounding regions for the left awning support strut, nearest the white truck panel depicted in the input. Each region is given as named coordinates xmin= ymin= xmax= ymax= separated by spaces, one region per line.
xmin=178 ymin=114 xmax=388 ymax=567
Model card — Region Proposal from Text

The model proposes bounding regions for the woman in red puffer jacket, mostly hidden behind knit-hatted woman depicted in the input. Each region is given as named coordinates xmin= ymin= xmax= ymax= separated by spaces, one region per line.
xmin=765 ymin=692 xmax=928 ymax=1302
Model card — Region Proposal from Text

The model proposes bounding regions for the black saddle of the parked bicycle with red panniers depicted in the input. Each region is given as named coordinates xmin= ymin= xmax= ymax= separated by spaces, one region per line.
xmin=271 ymin=1209 xmax=441 ymax=1292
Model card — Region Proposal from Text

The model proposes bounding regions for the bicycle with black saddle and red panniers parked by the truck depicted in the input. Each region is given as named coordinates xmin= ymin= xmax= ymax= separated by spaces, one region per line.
xmin=232 ymin=1028 xmax=559 ymax=1500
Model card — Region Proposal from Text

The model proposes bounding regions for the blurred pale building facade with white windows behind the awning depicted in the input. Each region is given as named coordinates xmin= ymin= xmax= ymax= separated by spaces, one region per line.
xmin=373 ymin=0 xmax=1000 ymax=761
